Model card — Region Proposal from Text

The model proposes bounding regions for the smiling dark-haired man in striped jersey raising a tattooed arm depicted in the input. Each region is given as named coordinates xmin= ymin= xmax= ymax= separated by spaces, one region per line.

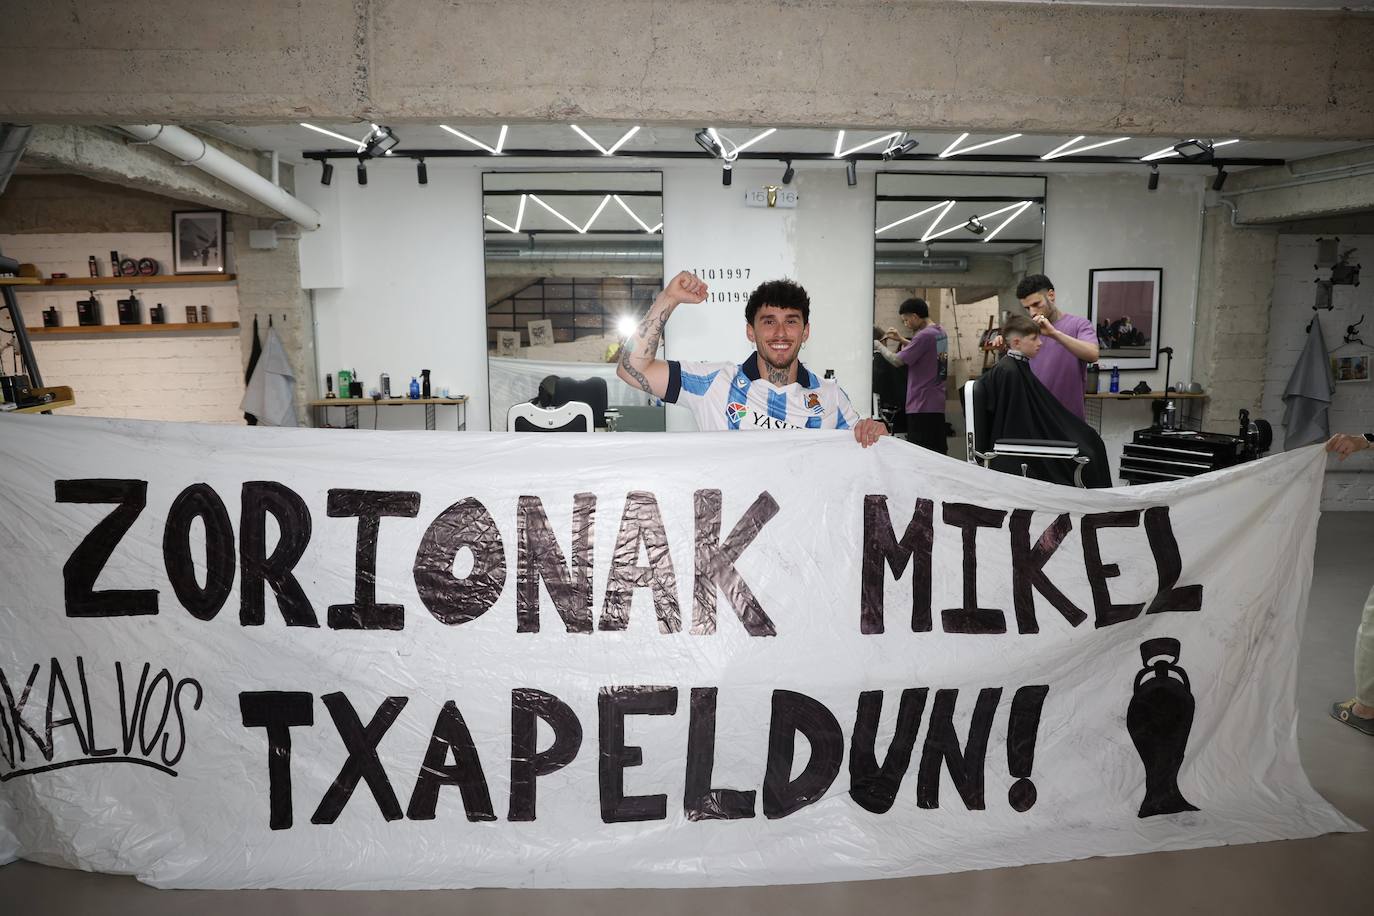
xmin=616 ymin=271 xmax=888 ymax=448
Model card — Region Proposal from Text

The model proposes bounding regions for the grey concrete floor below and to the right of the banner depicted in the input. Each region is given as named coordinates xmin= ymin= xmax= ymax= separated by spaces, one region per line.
xmin=0 ymin=512 xmax=1374 ymax=916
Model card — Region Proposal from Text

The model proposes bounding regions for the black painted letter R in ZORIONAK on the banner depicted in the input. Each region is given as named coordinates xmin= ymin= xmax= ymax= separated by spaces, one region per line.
xmin=239 ymin=481 xmax=320 ymax=626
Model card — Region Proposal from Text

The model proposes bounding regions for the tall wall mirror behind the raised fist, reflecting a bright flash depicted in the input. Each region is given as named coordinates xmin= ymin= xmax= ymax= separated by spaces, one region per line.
xmin=482 ymin=172 xmax=664 ymax=431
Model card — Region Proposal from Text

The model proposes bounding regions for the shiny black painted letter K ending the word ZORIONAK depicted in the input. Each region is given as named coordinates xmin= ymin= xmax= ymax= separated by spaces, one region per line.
xmin=691 ymin=490 xmax=778 ymax=636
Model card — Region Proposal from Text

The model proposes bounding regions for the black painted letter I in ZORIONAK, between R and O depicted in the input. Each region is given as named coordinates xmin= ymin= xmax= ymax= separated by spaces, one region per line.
xmin=327 ymin=490 xmax=420 ymax=630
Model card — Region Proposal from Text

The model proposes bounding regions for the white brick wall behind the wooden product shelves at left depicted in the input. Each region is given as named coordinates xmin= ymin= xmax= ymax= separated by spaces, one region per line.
xmin=0 ymin=232 xmax=243 ymax=423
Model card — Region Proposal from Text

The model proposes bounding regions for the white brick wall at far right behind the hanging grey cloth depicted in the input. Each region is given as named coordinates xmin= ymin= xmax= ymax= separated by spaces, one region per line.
xmin=1264 ymin=235 xmax=1374 ymax=512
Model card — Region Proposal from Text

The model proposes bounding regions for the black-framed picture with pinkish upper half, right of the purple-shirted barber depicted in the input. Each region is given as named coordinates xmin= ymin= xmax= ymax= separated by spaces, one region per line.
xmin=1088 ymin=268 xmax=1164 ymax=369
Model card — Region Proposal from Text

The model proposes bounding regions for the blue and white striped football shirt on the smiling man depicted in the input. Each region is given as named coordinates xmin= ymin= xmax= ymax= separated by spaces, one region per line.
xmin=664 ymin=353 xmax=859 ymax=433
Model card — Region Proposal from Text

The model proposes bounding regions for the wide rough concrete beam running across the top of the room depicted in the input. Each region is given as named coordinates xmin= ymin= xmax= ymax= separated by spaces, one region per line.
xmin=0 ymin=0 xmax=1374 ymax=140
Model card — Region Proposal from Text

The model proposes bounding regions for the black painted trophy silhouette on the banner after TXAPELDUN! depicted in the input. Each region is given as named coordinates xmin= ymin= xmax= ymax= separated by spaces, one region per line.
xmin=1125 ymin=637 xmax=1197 ymax=817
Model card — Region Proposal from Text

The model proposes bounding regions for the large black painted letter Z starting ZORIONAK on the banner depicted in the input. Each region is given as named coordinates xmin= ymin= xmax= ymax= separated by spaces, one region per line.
xmin=52 ymin=478 xmax=158 ymax=617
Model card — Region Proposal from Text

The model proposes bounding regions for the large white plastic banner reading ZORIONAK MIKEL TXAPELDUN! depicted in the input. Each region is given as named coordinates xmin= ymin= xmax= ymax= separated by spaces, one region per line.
xmin=0 ymin=416 xmax=1359 ymax=889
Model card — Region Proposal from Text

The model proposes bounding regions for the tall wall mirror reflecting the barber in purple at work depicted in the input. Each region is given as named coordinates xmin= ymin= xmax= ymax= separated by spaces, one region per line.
xmin=872 ymin=172 xmax=1046 ymax=428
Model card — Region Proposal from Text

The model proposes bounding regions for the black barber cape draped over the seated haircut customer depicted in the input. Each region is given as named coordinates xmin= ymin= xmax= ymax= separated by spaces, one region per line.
xmin=973 ymin=353 xmax=1112 ymax=488
